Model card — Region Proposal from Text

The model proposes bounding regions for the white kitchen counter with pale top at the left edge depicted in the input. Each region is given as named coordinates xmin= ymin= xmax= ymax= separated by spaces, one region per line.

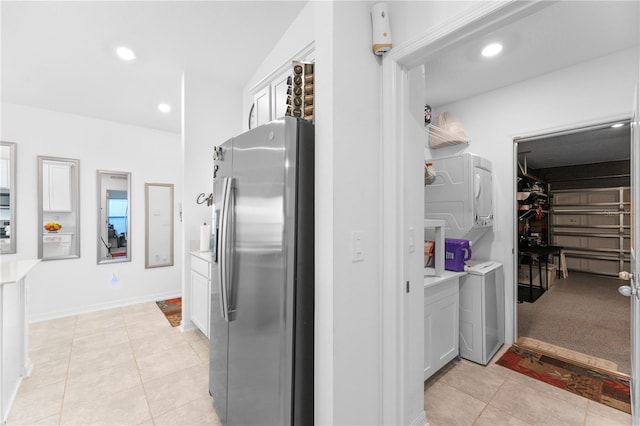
xmin=0 ymin=260 xmax=40 ymax=424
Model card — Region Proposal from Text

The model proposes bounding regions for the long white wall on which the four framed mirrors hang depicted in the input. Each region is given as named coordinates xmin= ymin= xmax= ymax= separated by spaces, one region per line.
xmin=0 ymin=103 xmax=182 ymax=321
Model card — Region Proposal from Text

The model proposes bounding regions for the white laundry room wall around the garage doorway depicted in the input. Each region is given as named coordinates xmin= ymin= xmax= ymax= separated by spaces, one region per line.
xmin=425 ymin=48 xmax=638 ymax=339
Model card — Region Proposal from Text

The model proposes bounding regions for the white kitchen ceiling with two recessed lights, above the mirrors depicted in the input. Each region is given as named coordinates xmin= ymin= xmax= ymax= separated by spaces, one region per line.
xmin=0 ymin=0 xmax=306 ymax=133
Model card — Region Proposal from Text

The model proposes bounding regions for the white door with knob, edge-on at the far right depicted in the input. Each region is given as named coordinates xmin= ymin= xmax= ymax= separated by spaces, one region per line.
xmin=619 ymin=87 xmax=640 ymax=426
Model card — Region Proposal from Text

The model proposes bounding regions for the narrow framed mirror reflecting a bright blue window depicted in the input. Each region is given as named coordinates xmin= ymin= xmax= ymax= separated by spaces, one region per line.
xmin=96 ymin=170 xmax=131 ymax=264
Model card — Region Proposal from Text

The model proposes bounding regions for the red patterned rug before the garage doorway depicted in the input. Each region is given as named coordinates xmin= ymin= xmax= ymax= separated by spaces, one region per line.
xmin=496 ymin=344 xmax=631 ymax=413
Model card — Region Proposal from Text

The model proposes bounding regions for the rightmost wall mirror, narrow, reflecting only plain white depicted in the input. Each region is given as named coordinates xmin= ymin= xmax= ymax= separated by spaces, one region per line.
xmin=144 ymin=183 xmax=173 ymax=268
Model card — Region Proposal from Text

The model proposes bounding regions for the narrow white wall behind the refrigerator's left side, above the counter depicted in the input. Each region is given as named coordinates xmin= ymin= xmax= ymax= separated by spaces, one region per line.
xmin=177 ymin=71 xmax=242 ymax=329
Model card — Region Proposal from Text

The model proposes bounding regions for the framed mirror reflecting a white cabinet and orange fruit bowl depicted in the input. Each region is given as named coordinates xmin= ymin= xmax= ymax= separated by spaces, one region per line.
xmin=38 ymin=156 xmax=80 ymax=260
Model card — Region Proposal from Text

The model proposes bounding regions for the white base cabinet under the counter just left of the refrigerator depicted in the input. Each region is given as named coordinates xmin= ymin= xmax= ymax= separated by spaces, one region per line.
xmin=190 ymin=252 xmax=211 ymax=337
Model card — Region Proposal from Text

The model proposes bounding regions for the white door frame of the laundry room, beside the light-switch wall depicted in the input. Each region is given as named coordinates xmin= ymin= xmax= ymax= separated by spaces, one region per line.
xmin=379 ymin=2 xmax=545 ymax=425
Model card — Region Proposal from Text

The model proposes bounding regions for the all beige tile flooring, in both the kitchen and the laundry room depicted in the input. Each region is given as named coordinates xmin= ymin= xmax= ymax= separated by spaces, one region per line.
xmin=7 ymin=303 xmax=631 ymax=426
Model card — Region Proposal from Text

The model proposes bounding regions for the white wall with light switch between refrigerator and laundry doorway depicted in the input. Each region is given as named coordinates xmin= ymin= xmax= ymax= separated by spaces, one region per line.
xmin=245 ymin=2 xmax=383 ymax=425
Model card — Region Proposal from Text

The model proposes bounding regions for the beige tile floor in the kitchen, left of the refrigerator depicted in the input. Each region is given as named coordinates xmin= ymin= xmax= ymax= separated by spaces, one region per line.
xmin=7 ymin=302 xmax=220 ymax=425
